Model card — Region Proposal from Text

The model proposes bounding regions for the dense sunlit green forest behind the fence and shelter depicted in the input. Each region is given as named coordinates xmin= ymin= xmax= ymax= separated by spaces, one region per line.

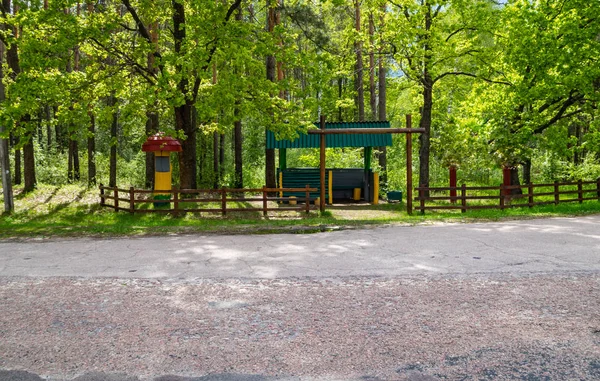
xmin=0 ymin=0 xmax=600 ymax=211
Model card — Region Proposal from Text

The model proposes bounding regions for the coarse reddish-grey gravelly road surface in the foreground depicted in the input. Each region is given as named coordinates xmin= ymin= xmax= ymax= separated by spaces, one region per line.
xmin=0 ymin=273 xmax=600 ymax=380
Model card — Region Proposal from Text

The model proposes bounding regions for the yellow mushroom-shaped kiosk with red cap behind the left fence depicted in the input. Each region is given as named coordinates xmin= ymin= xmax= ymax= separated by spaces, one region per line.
xmin=142 ymin=132 xmax=182 ymax=207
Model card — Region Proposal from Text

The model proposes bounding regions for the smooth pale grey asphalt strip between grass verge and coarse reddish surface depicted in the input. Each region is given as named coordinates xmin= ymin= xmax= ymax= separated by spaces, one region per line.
xmin=0 ymin=216 xmax=600 ymax=279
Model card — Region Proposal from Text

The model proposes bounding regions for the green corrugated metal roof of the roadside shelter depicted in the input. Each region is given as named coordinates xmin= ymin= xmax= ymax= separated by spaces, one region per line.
xmin=267 ymin=121 xmax=392 ymax=149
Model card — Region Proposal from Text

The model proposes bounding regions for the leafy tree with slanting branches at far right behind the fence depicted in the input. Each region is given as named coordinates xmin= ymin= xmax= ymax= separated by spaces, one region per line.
xmin=482 ymin=0 xmax=600 ymax=184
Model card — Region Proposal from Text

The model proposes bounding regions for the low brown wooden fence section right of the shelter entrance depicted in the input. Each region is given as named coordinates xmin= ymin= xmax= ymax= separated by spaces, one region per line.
xmin=415 ymin=179 xmax=600 ymax=213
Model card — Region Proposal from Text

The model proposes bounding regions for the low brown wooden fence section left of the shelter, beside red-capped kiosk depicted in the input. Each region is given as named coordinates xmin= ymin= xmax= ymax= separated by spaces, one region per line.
xmin=100 ymin=184 xmax=318 ymax=216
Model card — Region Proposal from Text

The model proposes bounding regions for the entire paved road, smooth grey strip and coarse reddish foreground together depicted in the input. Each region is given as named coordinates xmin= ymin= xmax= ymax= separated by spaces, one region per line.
xmin=0 ymin=216 xmax=600 ymax=381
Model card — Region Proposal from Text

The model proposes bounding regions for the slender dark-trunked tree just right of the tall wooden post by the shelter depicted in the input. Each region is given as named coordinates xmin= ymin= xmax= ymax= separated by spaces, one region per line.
xmin=387 ymin=0 xmax=495 ymax=190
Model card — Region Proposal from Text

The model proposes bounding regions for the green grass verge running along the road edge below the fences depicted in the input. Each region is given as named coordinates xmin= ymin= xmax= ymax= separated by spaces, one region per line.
xmin=0 ymin=185 xmax=600 ymax=239
